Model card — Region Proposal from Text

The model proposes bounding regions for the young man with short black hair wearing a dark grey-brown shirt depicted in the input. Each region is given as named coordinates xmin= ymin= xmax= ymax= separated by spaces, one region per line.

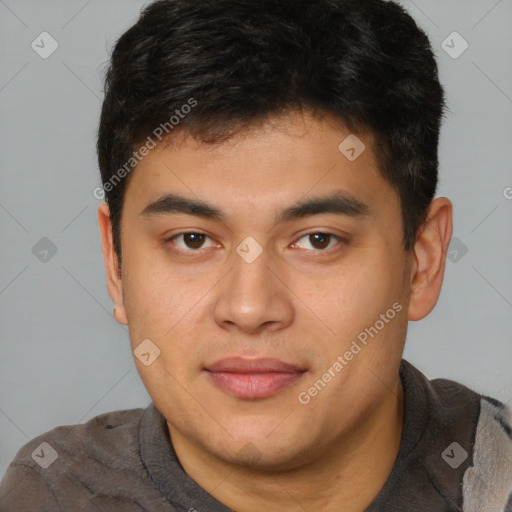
xmin=0 ymin=0 xmax=512 ymax=512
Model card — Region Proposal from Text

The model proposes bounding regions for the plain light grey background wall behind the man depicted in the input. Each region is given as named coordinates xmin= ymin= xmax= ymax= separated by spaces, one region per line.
xmin=0 ymin=0 xmax=512 ymax=475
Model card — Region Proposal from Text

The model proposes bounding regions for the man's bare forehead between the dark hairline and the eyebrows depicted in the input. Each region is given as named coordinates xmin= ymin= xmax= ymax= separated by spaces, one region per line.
xmin=125 ymin=111 xmax=397 ymax=225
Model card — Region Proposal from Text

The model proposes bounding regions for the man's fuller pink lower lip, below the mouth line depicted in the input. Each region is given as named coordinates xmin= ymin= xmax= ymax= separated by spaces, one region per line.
xmin=207 ymin=371 xmax=304 ymax=399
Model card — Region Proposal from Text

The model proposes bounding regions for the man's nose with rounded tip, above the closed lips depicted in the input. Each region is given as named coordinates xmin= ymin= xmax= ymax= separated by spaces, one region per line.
xmin=214 ymin=244 xmax=294 ymax=334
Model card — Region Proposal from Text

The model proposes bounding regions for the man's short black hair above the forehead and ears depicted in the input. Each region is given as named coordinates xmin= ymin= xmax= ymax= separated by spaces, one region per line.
xmin=97 ymin=0 xmax=445 ymax=260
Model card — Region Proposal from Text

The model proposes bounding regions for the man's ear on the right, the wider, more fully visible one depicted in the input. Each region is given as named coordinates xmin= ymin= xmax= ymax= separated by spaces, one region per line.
xmin=408 ymin=197 xmax=453 ymax=321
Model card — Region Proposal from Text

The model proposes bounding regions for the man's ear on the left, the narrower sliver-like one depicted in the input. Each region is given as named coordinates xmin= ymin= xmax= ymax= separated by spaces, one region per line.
xmin=98 ymin=202 xmax=128 ymax=325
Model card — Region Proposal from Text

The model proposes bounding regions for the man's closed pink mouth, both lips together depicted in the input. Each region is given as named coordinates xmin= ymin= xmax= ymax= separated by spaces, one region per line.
xmin=203 ymin=357 xmax=307 ymax=400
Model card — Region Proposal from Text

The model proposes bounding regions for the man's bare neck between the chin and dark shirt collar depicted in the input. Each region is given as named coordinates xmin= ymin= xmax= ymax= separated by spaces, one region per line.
xmin=168 ymin=378 xmax=403 ymax=512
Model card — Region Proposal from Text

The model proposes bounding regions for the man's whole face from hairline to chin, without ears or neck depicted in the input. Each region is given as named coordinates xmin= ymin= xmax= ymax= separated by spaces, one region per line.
xmin=102 ymin=114 xmax=411 ymax=468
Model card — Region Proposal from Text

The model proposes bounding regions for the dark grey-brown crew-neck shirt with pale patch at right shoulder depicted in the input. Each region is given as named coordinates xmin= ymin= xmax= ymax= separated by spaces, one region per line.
xmin=0 ymin=360 xmax=512 ymax=512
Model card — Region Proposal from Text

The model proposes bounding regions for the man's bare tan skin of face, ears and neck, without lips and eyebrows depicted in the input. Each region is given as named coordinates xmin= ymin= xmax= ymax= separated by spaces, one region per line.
xmin=98 ymin=113 xmax=452 ymax=512
